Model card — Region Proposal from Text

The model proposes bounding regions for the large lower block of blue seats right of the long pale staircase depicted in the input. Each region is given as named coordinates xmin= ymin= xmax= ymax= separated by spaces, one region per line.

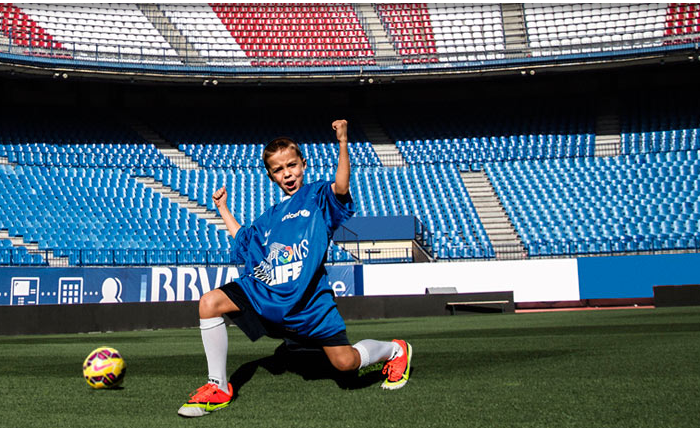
xmin=486 ymin=151 xmax=700 ymax=256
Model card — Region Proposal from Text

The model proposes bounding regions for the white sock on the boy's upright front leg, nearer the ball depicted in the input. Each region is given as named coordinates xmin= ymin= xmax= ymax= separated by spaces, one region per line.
xmin=199 ymin=317 xmax=231 ymax=393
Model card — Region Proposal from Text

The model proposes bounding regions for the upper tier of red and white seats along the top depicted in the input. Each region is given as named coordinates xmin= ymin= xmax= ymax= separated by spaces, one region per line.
xmin=0 ymin=3 xmax=700 ymax=72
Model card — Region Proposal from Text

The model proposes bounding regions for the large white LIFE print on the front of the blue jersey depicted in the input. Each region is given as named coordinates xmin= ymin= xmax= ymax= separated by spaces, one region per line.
xmin=253 ymin=239 xmax=309 ymax=285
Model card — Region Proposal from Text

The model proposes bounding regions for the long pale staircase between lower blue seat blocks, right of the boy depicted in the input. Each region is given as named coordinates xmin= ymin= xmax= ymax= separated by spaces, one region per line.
xmin=460 ymin=171 xmax=526 ymax=259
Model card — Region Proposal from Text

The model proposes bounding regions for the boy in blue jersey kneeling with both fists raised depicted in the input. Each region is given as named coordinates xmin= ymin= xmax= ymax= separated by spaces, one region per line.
xmin=178 ymin=120 xmax=412 ymax=417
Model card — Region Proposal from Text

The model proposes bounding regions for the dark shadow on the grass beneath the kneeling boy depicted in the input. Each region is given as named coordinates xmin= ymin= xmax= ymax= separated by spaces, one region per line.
xmin=229 ymin=343 xmax=384 ymax=399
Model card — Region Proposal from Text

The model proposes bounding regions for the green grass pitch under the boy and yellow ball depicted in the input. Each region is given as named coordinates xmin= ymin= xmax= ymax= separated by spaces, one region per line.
xmin=0 ymin=307 xmax=700 ymax=428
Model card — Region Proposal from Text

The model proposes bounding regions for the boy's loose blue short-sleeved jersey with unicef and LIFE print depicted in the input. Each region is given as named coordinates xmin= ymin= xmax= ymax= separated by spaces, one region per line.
xmin=233 ymin=181 xmax=354 ymax=338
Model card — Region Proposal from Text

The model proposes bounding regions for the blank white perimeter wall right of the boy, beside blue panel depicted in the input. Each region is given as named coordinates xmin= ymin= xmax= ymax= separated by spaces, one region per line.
xmin=363 ymin=259 xmax=580 ymax=302
